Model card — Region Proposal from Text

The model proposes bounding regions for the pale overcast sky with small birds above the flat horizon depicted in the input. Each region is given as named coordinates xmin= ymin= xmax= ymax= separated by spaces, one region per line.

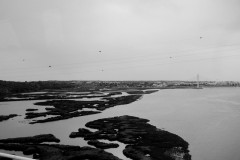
xmin=0 ymin=0 xmax=240 ymax=81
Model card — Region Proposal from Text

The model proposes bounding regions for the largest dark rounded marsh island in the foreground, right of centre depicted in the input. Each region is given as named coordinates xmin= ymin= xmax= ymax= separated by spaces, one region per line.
xmin=70 ymin=116 xmax=191 ymax=160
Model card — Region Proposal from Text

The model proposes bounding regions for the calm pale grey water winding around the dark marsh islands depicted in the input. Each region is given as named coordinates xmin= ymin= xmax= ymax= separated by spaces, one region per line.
xmin=0 ymin=88 xmax=240 ymax=160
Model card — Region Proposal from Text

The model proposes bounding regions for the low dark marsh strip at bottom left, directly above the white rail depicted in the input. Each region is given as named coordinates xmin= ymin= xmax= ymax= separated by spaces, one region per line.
xmin=0 ymin=143 xmax=120 ymax=160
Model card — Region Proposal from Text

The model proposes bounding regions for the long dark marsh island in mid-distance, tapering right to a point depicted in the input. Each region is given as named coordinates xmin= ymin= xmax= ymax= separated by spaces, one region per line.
xmin=25 ymin=95 xmax=141 ymax=124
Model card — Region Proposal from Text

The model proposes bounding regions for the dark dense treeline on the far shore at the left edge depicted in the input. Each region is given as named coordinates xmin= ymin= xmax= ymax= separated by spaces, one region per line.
xmin=0 ymin=80 xmax=75 ymax=98
